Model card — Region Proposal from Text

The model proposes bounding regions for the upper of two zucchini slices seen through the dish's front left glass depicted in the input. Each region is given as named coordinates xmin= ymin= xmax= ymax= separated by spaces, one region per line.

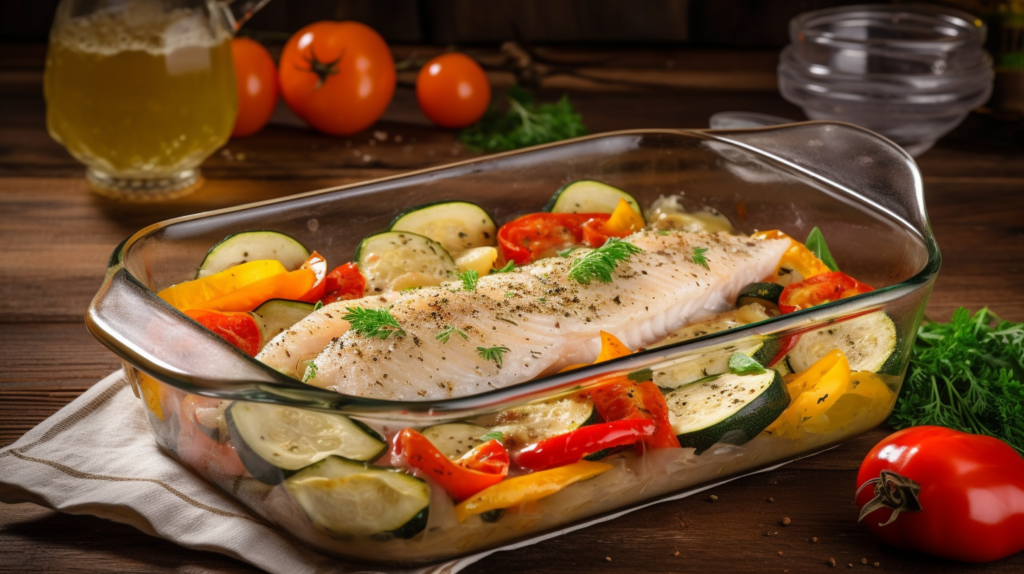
xmin=226 ymin=401 xmax=387 ymax=484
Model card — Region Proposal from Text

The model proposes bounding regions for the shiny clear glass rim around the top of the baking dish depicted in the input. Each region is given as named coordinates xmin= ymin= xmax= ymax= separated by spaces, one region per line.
xmin=86 ymin=121 xmax=941 ymax=421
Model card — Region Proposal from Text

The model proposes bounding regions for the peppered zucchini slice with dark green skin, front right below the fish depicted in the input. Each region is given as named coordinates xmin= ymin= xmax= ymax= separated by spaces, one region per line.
xmin=665 ymin=370 xmax=790 ymax=454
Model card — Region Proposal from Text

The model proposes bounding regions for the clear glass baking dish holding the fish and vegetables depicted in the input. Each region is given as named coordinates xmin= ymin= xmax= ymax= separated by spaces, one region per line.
xmin=87 ymin=122 xmax=940 ymax=565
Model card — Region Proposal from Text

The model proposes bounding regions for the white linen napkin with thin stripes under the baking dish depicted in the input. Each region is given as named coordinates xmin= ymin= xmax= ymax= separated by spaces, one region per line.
xmin=0 ymin=370 xmax=815 ymax=574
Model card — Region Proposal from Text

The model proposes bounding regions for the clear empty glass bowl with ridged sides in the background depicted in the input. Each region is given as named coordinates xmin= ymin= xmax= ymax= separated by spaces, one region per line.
xmin=778 ymin=4 xmax=994 ymax=156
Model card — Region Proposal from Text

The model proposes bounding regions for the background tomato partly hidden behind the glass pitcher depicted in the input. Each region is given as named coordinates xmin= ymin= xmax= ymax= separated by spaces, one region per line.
xmin=231 ymin=38 xmax=278 ymax=137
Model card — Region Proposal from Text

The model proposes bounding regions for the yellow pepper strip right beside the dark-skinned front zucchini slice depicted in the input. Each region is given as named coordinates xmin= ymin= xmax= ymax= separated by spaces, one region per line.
xmin=765 ymin=349 xmax=850 ymax=436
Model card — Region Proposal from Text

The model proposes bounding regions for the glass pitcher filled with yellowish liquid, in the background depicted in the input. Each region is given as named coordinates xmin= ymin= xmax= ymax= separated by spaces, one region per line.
xmin=44 ymin=0 xmax=268 ymax=201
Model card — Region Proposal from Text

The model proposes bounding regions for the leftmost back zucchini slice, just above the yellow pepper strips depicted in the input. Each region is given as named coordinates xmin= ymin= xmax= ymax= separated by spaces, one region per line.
xmin=196 ymin=230 xmax=309 ymax=279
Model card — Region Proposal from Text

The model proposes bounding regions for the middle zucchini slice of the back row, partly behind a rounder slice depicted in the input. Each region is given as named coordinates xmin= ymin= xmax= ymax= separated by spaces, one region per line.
xmin=390 ymin=202 xmax=498 ymax=256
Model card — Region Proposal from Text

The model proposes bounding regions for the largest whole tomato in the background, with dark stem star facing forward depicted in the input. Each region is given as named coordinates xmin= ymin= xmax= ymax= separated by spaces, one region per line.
xmin=280 ymin=21 xmax=395 ymax=135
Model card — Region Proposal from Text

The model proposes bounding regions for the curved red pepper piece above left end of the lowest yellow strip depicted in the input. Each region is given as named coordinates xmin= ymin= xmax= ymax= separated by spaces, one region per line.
xmin=395 ymin=429 xmax=509 ymax=500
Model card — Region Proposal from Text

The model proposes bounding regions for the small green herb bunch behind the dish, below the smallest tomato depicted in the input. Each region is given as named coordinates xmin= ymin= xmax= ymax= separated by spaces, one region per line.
xmin=459 ymin=86 xmax=587 ymax=151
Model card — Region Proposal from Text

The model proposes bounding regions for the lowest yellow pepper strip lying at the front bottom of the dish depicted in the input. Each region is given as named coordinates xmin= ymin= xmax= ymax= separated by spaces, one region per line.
xmin=455 ymin=460 xmax=611 ymax=522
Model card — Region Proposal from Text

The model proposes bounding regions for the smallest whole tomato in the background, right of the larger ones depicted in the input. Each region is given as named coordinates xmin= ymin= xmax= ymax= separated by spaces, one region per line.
xmin=416 ymin=52 xmax=490 ymax=128
